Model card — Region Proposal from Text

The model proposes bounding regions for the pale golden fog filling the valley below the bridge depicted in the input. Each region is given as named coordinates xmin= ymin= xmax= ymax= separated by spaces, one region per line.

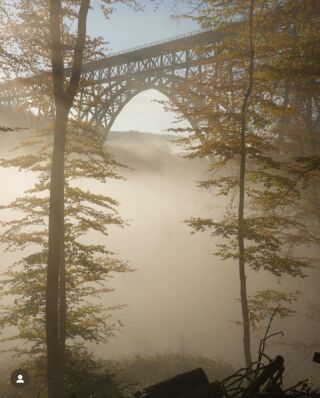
xmin=0 ymin=116 xmax=319 ymax=380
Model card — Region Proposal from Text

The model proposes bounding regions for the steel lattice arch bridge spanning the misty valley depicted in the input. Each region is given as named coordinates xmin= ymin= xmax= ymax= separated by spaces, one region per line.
xmin=0 ymin=30 xmax=220 ymax=131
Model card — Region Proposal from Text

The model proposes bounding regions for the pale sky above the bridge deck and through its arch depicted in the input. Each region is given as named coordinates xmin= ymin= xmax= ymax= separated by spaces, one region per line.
xmin=88 ymin=0 xmax=199 ymax=133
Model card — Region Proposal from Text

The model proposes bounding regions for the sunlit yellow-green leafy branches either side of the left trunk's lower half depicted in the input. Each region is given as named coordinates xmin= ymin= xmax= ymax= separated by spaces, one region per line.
xmin=0 ymin=122 xmax=129 ymax=398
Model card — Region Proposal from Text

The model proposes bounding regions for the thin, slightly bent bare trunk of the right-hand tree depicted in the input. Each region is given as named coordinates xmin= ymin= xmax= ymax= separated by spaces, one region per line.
xmin=238 ymin=0 xmax=254 ymax=366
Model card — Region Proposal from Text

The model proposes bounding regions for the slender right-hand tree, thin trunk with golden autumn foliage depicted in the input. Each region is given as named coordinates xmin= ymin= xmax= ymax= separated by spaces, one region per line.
xmin=168 ymin=0 xmax=318 ymax=365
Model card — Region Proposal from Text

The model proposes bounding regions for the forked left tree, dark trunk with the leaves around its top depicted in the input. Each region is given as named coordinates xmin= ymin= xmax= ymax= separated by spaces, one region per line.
xmin=0 ymin=0 xmax=135 ymax=398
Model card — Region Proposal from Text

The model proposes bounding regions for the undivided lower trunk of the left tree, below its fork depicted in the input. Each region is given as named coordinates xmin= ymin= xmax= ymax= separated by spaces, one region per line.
xmin=46 ymin=100 xmax=68 ymax=398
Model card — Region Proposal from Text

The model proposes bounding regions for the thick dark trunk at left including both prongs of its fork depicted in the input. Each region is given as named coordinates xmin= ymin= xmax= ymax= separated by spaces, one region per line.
xmin=46 ymin=0 xmax=90 ymax=398
